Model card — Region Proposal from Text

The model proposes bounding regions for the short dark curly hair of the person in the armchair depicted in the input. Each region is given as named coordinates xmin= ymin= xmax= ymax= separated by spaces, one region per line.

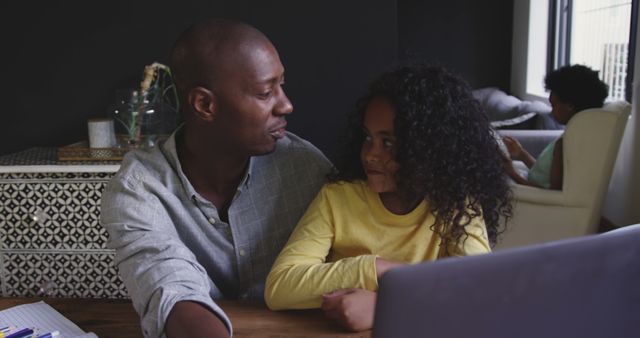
xmin=544 ymin=65 xmax=609 ymax=112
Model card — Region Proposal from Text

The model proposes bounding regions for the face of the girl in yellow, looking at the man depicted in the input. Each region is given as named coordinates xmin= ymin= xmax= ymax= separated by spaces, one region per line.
xmin=360 ymin=97 xmax=399 ymax=193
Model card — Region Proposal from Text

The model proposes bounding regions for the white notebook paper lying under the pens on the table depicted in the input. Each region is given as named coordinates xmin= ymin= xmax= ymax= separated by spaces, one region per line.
xmin=0 ymin=301 xmax=98 ymax=338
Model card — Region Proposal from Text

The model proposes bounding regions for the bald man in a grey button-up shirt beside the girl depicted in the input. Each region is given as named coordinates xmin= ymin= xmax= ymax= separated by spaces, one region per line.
xmin=101 ymin=20 xmax=331 ymax=338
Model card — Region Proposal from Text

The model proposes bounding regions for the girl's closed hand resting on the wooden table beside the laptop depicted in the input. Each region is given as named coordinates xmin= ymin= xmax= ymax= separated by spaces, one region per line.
xmin=322 ymin=289 xmax=377 ymax=331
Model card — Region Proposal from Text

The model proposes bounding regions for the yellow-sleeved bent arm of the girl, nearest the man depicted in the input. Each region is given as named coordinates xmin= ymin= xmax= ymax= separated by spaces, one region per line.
xmin=265 ymin=189 xmax=378 ymax=310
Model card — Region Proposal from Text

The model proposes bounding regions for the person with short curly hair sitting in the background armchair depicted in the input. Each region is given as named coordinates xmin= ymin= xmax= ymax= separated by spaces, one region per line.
xmin=503 ymin=65 xmax=609 ymax=190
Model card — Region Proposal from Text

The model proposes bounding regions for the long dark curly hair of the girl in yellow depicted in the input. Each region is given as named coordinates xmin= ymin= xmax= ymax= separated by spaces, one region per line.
xmin=329 ymin=64 xmax=511 ymax=247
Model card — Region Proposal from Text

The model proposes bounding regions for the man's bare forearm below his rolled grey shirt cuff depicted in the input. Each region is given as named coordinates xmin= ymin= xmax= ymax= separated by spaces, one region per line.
xmin=165 ymin=301 xmax=229 ymax=338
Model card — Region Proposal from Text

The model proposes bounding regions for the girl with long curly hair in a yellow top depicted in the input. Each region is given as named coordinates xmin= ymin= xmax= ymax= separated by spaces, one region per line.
xmin=265 ymin=66 xmax=511 ymax=331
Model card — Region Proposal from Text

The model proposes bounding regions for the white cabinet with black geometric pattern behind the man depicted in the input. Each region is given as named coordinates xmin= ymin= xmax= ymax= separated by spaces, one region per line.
xmin=0 ymin=148 xmax=127 ymax=298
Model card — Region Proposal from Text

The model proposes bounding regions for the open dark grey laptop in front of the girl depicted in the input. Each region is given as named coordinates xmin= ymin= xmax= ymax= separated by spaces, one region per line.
xmin=373 ymin=224 xmax=640 ymax=338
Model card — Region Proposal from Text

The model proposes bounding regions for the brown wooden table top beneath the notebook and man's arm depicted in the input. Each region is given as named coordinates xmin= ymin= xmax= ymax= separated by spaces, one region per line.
xmin=0 ymin=298 xmax=371 ymax=338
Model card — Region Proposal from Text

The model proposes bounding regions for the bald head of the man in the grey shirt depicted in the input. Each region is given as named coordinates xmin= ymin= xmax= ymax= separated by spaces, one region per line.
xmin=171 ymin=20 xmax=293 ymax=155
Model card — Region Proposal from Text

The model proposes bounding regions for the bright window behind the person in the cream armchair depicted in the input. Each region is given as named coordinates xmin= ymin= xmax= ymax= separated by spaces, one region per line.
xmin=511 ymin=0 xmax=639 ymax=102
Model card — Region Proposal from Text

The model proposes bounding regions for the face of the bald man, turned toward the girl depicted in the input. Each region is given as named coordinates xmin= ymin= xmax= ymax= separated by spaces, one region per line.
xmin=213 ymin=42 xmax=293 ymax=156
